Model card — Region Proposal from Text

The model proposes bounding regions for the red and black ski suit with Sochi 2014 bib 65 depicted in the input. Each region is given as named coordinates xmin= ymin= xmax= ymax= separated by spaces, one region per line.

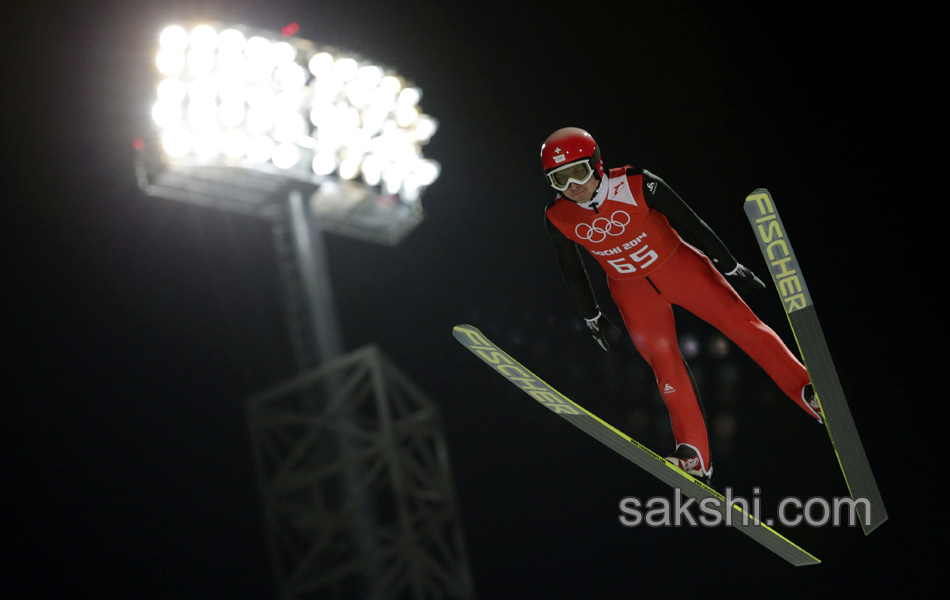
xmin=545 ymin=167 xmax=817 ymax=474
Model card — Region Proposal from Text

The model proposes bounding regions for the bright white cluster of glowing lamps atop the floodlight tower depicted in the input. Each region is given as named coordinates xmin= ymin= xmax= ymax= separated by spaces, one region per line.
xmin=151 ymin=24 xmax=439 ymax=205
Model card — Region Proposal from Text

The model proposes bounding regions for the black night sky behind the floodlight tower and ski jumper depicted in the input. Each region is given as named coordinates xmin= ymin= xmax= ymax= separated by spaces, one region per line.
xmin=0 ymin=0 xmax=947 ymax=599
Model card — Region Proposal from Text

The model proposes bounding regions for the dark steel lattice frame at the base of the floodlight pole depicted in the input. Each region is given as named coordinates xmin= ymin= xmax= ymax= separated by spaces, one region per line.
xmin=247 ymin=346 xmax=474 ymax=599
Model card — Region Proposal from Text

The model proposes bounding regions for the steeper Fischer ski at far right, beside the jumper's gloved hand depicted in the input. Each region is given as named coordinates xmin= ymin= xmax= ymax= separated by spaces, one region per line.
xmin=744 ymin=188 xmax=887 ymax=535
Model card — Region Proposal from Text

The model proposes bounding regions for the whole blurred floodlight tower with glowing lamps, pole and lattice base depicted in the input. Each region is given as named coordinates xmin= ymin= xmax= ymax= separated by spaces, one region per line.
xmin=136 ymin=23 xmax=474 ymax=599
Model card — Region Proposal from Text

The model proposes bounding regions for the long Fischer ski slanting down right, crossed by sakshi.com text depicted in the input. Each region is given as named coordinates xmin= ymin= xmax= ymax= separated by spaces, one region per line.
xmin=452 ymin=325 xmax=821 ymax=566
